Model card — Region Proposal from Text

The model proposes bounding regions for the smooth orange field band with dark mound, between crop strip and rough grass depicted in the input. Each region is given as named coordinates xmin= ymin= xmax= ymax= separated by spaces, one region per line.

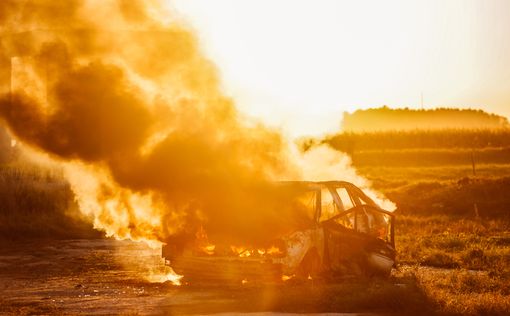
xmin=358 ymin=165 xmax=510 ymax=219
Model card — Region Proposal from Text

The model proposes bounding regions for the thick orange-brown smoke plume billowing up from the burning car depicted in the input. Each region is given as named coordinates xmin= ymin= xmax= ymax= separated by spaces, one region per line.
xmin=0 ymin=0 xmax=394 ymax=247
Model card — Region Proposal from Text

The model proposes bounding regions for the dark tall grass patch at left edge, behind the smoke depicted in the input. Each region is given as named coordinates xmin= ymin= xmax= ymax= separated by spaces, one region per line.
xmin=0 ymin=164 xmax=100 ymax=239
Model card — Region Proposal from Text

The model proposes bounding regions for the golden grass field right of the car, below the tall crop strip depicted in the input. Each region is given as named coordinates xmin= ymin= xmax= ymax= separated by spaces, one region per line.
xmin=357 ymin=159 xmax=510 ymax=315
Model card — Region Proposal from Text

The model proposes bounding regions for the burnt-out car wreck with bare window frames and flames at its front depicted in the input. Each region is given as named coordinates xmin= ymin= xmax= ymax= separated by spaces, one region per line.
xmin=162 ymin=181 xmax=396 ymax=281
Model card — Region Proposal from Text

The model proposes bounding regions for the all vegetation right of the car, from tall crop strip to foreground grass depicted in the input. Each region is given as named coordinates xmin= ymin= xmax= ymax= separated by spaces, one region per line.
xmin=310 ymin=124 xmax=510 ymax=315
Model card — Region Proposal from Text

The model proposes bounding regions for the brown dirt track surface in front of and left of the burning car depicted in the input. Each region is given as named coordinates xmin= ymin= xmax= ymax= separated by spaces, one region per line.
xmin=0 ymin=240 xmax=398 ymax=315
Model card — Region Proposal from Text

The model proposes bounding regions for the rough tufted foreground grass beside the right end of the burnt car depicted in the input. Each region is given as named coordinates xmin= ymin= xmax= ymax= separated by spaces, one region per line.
xmin=397 ymin=215 xmax=510 ymax=315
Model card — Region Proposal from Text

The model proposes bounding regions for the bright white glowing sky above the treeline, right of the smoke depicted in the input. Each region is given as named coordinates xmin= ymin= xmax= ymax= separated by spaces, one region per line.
xmin=168 ymin=0 xmax=510 ymax=137
